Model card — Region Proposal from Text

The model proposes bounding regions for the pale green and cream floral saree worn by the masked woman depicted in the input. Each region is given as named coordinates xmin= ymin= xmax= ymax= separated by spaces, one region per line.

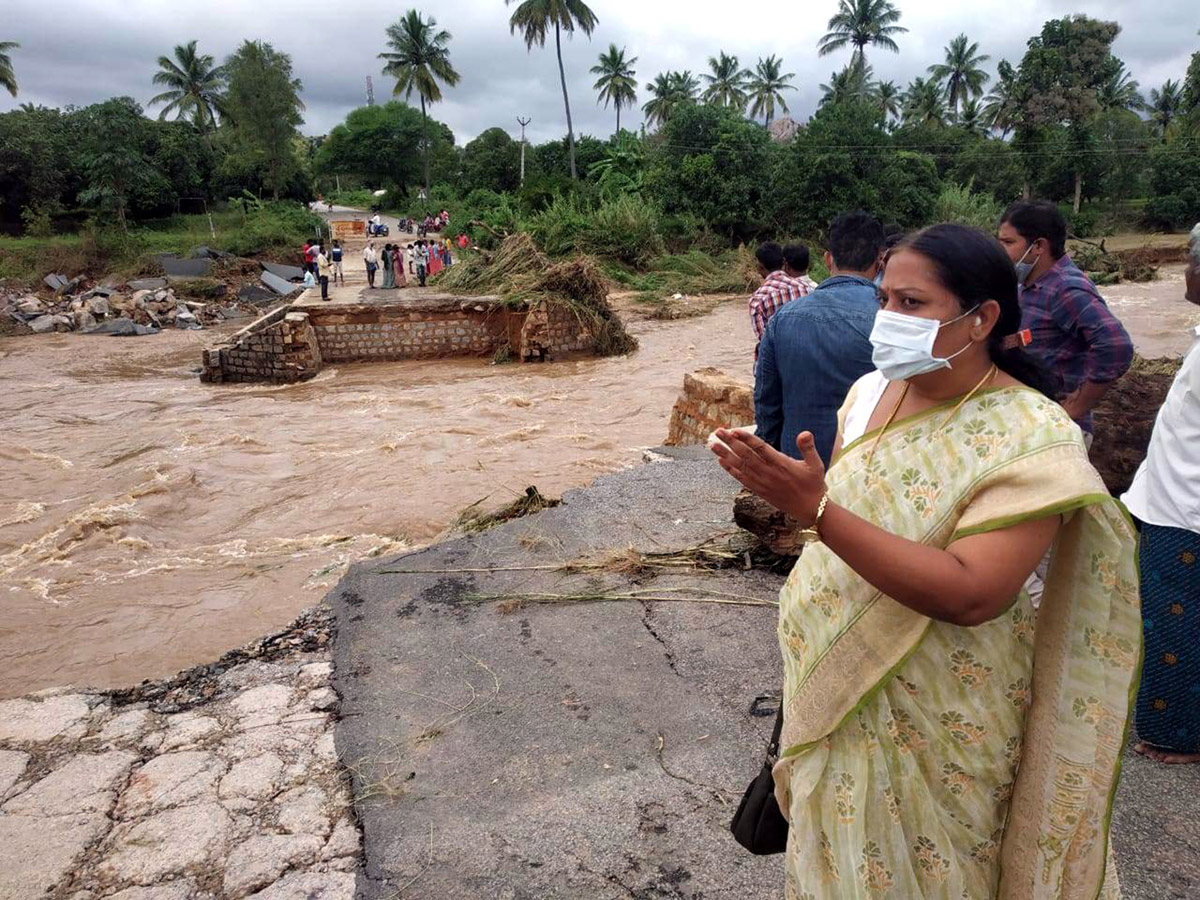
xmin=774 ymin=388 xmax=1141 ymax=900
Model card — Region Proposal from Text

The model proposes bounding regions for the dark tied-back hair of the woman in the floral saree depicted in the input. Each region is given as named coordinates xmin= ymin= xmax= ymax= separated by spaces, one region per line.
xmin=893 ymin=224 xmax=1062 ymax=400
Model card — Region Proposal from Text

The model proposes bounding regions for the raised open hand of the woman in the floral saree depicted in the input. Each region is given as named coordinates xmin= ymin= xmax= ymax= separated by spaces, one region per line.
xmin=712 ymin=428 xmax=826 ymax=527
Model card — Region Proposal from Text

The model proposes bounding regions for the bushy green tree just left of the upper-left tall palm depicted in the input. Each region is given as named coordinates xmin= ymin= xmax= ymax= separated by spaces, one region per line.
xmin=79 ymin=97 xmax=154 ymax=232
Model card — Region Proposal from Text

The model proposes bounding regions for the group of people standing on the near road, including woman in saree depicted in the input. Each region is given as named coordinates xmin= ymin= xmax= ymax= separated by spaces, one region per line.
xmin=713 ymin=203 xmax=1200 ymax=898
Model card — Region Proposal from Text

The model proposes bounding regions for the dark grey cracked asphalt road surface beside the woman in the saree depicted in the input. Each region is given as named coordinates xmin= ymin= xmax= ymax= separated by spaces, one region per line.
xmin=330 ymin=448 xmax=1200 ymax=900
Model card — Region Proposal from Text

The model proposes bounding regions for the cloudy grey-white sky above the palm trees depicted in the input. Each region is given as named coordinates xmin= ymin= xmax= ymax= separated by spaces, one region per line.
xmin=0 ymin=0 xmax=1200 ymax=142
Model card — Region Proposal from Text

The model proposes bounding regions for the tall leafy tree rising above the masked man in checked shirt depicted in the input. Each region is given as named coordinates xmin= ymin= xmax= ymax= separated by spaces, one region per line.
xmin=1016 ymin=16 xmax=1121 ymax=214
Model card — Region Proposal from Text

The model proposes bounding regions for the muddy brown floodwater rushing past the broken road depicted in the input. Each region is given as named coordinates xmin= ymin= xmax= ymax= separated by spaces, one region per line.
xmin=0 ymin=266 xmax=1200 ymax=697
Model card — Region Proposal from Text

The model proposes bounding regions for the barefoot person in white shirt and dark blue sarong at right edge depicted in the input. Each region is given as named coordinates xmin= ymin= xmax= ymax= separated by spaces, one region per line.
xmin=1121 ymin=224 xmax=1200 ymax=762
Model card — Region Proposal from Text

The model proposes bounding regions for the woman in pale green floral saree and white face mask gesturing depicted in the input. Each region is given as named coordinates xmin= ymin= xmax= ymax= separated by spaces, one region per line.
xmin=714 ymin=226 xmax=1141 ymax=900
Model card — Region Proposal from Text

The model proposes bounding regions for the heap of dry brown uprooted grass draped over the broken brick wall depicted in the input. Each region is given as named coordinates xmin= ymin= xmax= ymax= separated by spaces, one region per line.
xmin=433 ymin=232 xmax=637 ymax=356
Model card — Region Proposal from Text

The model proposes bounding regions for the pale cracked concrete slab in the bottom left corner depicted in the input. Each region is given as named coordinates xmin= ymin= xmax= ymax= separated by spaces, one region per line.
xmin=0 ymin=610 xmax=360 ymax=900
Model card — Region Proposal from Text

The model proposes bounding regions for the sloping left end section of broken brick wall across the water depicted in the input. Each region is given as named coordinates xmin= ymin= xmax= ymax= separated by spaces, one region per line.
xmin=200 ymin=305 xmax=322 ymax=384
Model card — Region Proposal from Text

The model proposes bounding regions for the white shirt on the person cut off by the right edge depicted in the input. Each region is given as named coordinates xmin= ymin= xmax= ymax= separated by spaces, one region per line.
xmin=1121 ymin=326 xmax=1200 ymax=533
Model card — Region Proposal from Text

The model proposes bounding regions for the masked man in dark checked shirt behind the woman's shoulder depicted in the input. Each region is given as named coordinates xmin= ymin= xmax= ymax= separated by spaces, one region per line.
xmin=996 ymin=202 xmax=1133 ymax=446
